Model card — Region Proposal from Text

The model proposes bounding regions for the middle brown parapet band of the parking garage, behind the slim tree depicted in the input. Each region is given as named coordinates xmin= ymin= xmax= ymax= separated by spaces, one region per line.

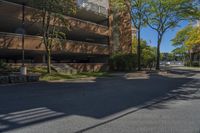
xmin=0 ymin=33 xmax=109 ymax=55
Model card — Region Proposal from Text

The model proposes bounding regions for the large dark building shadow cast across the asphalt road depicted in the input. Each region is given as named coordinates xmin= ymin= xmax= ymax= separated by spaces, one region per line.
xmin=0 ymin=71 xmax=199 ymax=132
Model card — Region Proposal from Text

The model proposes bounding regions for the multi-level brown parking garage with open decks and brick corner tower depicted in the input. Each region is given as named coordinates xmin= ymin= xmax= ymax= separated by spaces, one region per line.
xmin=0 ymin=0 xmax=132 ymax=71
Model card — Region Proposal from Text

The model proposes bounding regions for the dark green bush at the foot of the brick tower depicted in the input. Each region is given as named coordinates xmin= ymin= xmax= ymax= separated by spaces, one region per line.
xmin=109 ymin=53 xmax=137 ymax=71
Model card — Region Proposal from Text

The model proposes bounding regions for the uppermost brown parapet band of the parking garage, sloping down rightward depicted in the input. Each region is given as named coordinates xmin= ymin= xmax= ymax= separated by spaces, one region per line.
xmin=2 ymin=1 xmax=109 ymax=36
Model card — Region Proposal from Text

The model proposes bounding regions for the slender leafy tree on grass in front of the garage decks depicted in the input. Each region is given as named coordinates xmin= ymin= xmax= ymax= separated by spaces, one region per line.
xmin=30 ymin=0 xmax=75 ymax=73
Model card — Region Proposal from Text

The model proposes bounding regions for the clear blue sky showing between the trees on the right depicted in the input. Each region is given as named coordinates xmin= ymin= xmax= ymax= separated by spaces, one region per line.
xmin=141 ymin=21 xmax=188 ymax=52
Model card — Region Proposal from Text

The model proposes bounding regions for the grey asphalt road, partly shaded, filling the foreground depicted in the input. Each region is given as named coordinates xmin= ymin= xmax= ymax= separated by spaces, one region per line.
xmin=0 ymin=70 xmax=200 ymax=133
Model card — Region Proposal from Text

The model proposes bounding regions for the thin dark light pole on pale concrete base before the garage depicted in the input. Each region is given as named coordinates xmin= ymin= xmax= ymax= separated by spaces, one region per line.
xmin=20 ymin=3 xmax=27 ymax=75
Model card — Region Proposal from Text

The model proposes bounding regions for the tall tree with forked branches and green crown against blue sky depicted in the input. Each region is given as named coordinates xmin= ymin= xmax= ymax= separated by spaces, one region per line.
xmin=146 ymin=0 xmax=199 ymax=70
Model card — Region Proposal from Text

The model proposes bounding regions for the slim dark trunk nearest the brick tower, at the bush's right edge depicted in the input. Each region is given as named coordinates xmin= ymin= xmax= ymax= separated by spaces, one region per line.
xmin=137 ymin=28 xmax=141 ymax=71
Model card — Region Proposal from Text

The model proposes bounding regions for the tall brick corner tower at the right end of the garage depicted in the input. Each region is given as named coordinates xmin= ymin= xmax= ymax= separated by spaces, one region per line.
xmin=109 ymin=2 xmax=132 ymax=54
